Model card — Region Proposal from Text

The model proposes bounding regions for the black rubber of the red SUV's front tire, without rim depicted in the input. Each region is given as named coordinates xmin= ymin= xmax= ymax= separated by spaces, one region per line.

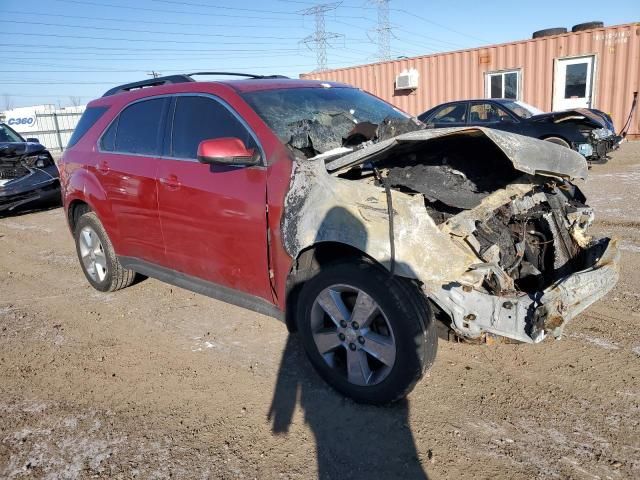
xmin=296 ymin=260 xmax=438 ymax=405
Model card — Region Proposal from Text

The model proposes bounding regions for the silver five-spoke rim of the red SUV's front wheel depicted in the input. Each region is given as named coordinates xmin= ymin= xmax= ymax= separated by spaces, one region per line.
xmin=311 ymin=284 xmax=396 ymax=386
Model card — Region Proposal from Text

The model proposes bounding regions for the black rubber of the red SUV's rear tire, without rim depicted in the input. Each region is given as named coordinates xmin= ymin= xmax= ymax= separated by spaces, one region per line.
xmin=73 ymin=212 xmax=136 ymax=292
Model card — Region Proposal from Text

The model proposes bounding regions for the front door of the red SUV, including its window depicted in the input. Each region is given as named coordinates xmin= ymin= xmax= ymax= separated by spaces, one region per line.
xmin=158 ymin=94 xmax=272 ymax=301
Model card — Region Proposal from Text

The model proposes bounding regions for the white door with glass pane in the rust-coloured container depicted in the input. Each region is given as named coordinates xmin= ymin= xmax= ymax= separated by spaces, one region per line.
xmin=553 ymin=55 xmax=595 ymax=111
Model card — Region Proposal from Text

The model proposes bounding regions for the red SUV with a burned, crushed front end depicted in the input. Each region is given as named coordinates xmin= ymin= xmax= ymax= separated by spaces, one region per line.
xmin=61 ymin=74 xmax=618 ymax=403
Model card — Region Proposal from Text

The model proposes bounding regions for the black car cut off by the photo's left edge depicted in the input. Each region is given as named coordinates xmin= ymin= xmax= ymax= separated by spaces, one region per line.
xmin=0 ymin=123 xmax=60 ymax=214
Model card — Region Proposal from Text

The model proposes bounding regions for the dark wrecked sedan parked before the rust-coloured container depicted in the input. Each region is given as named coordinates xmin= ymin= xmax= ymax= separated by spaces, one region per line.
xmin=418 ymin=98 xmax=622 ymax=163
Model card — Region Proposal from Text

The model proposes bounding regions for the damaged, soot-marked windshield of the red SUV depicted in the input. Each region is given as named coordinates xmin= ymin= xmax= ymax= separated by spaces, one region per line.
xmin=242 ymin=87 xmax=420 ymax=156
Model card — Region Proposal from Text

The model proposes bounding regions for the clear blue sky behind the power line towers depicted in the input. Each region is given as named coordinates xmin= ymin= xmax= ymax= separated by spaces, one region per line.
xmin=0 ymin=0 xmax=640 ymax=111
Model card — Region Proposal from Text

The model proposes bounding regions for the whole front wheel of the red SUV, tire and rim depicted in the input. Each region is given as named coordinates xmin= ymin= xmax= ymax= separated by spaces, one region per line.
xmin=296 ymin=260 xmax=438 ymax=405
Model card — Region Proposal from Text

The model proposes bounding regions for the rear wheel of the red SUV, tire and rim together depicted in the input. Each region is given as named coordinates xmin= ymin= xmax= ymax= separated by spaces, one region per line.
xmin=73 ymin=212 xmax=136 ymax=292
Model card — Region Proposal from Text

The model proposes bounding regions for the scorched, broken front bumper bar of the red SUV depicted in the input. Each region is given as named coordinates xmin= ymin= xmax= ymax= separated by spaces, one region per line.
xmin=434 ymin=238 xmax=620 ymax=343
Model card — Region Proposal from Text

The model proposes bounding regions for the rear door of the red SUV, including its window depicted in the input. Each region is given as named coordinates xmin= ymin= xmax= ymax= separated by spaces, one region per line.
xmin=92 ymin=97 xmax=171 ymax=265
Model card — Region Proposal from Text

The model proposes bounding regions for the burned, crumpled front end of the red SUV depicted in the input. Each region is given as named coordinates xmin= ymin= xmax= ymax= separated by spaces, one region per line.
xmin=283 ymin=128 xmax=619 ymax=343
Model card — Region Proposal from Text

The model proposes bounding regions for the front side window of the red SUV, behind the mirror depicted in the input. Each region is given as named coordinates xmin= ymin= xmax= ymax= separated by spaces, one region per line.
xmin=170 ymin=96 xmax=257 ymax=159
